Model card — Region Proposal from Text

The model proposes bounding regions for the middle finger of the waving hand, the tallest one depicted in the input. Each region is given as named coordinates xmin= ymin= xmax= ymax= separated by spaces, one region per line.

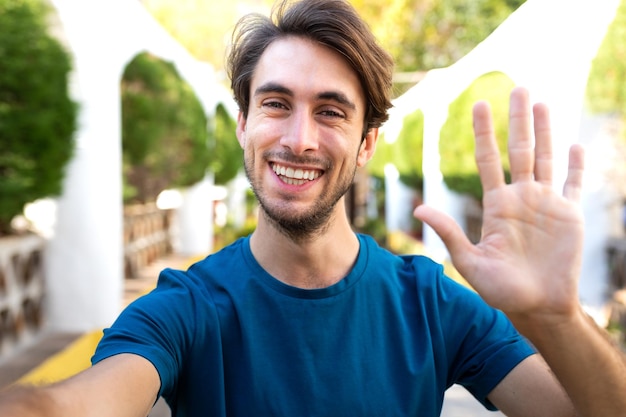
xmin=509 ymin=87 xmax=534 ymax=182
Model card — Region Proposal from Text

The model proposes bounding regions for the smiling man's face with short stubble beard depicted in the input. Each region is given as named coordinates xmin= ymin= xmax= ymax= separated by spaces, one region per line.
xmin=237 ymin=37 xmax=377 ymax=237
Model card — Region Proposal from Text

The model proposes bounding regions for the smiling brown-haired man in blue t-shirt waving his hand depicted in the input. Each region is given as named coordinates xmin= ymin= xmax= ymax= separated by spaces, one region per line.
xmin=0 ymin=0 xmax=626 ymax=417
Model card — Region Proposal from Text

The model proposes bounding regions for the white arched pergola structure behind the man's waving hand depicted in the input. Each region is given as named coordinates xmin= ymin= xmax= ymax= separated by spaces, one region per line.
xmin=385 ymin=0 xmax=619 ymax=312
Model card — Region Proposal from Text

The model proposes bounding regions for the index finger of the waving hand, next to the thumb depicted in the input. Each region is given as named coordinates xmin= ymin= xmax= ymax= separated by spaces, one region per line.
xmin=473 ymin=101 xmax=505 ymax=192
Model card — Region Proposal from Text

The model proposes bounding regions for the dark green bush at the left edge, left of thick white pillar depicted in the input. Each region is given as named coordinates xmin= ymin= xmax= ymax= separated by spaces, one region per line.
xmin=0 ymin=0 xmax=77 ymax=234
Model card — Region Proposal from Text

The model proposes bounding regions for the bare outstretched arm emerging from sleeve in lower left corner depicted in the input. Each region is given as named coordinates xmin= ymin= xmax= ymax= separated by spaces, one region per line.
xmin=0 ymin=354 xmax=160 ymax=417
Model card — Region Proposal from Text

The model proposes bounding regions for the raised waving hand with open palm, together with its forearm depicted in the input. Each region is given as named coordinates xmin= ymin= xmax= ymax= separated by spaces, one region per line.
xmin=415 ymin=88 xmax=626 ymax=417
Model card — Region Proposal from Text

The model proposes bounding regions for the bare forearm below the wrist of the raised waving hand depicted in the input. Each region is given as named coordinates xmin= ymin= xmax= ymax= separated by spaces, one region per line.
xmin=522 ymin=310 xmax=626 ymax=417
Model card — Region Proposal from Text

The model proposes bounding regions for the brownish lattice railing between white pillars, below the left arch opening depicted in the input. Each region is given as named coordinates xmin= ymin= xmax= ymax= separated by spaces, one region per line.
xmin=124 ymin=204 xmax=174 ymax=278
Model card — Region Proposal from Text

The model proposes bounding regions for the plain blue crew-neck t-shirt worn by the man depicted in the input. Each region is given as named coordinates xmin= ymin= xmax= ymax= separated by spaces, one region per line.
xmin=92 ymin=235 xmax=533 ymax=417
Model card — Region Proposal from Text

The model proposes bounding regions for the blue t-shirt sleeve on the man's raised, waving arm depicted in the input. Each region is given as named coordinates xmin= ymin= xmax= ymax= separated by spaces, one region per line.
xmin=432 ymin=260 xmax=535 ymax=410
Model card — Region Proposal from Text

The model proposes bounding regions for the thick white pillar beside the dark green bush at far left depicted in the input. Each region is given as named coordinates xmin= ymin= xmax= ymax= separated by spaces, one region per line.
xmin=46 ymin=3 xmax=123 ymax=331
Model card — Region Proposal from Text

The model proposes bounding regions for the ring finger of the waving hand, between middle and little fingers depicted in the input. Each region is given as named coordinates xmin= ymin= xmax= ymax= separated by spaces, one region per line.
xmin=533 ymin=103 xmax=553 ymax=185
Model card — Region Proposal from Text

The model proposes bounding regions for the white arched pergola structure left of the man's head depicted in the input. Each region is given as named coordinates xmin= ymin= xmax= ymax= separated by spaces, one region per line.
xmin=46 ymin=0 xmax=234 ymax=331
